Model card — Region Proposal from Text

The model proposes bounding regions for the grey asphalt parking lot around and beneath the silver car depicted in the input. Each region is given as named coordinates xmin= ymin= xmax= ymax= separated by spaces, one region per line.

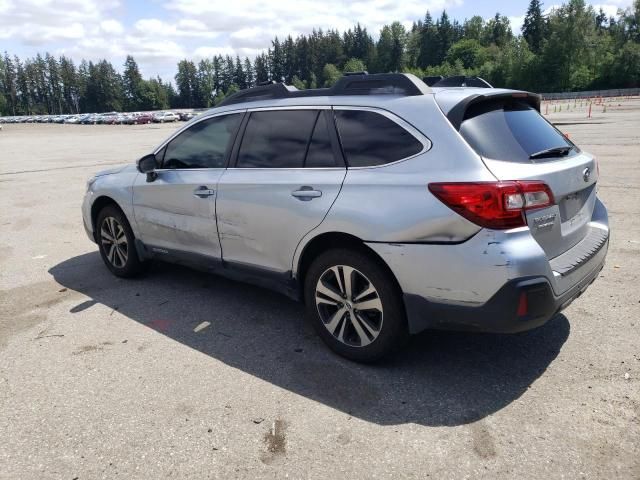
xmin=0 ymin=100 xmax=640 ymax=480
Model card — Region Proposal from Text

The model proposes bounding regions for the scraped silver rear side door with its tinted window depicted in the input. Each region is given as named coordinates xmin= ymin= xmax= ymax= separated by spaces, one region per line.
xmin=216 ymin=107 xmax=346 ymax=273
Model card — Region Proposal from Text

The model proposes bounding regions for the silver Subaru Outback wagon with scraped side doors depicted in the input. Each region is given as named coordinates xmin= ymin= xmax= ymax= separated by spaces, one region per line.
xmin=82 ymin=74 xmax=609 ymax=361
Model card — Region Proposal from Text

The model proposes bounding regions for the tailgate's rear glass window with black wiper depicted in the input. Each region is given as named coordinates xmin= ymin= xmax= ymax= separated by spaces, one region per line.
xmin=460 ymin=101 xmax=577 ymax=163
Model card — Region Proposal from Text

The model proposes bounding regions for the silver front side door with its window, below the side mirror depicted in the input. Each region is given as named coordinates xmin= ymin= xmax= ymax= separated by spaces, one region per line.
xmin=133 ymin=113 xmax=242 ymax=259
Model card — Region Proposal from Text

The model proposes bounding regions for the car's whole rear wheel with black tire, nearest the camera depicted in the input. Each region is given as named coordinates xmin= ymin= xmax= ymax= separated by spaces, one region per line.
xmin=304 ymin=249 xmax=409 ymax=363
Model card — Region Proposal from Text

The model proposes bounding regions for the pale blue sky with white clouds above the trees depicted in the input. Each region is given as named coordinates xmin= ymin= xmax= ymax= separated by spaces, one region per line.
xmin=0 ymin=0 xmax=632 ymax=80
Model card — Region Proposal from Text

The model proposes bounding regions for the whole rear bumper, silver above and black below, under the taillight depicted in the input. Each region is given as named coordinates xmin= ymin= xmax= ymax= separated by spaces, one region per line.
xmin=367 ymin=198 xmax=609 ymax=333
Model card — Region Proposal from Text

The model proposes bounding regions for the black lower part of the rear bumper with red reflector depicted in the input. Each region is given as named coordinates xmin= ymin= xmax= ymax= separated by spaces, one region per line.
xmin=404 ymin=241 xmax=609 ymax=333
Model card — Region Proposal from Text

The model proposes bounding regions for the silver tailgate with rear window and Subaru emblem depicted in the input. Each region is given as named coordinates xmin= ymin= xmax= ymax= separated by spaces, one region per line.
xmin=460 ymin=98 xmax=598 ymax=258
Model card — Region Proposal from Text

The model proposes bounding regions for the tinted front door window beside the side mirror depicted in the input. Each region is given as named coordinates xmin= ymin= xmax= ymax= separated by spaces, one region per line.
xmin=163 ymin=113 xmax=241 ymax=168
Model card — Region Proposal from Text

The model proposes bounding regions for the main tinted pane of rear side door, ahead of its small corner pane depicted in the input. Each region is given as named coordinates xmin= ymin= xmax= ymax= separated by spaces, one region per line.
xmin=237 ymin=110 xmax=318 ymax=168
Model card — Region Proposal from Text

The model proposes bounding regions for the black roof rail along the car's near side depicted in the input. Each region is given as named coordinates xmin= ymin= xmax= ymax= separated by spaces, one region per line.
xmin=217 ymin=72 xmax=431 ymax=107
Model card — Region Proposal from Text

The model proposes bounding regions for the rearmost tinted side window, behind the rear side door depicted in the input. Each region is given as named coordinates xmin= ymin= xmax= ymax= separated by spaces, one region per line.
xmin=335 ymin=110 xmax=422 ymax=167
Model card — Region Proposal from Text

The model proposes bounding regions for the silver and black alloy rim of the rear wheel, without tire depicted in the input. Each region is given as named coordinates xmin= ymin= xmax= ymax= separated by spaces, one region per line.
xmin=315 ymin=265 xmax=383 ymax=347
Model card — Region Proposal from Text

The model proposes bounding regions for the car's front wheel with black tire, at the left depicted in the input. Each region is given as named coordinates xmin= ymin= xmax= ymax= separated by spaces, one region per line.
xmin=95 ymin=205 xmax=143 ymax=278
